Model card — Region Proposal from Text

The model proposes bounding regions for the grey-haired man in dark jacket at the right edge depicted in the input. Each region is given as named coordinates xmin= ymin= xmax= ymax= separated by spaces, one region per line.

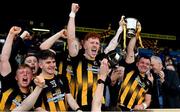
xmin=151 ymin=56 xmax=180 ymax=108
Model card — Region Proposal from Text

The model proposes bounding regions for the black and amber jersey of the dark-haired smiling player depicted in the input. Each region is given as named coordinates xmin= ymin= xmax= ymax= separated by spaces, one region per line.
xmin=35 ymin=74 xmax=70 ymax=111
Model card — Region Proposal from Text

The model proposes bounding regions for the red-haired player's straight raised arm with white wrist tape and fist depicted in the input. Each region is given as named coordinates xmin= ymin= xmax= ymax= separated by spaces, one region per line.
xmin=67 ymin=3 xmax=79 ymax=57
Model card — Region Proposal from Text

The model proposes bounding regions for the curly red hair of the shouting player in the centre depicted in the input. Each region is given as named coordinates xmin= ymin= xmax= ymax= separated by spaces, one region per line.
xmin=83 ymin=32 xmax=101 ymax=42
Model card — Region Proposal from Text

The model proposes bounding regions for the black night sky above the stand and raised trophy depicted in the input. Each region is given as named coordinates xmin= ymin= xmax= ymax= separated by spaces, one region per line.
xmin=0 ymin=0 xmax=177 ymax=39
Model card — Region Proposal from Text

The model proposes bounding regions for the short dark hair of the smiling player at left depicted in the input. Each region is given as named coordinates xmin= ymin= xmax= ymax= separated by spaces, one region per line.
xmin=38 ymin=49 xmax=56 ymax=60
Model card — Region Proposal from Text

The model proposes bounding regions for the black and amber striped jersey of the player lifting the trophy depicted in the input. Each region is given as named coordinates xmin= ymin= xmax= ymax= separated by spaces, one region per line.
xmin=118 ymin=63 xmax=152 ymax=109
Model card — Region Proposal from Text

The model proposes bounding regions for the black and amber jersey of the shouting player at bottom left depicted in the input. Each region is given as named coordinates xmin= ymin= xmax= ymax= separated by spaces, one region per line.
xmin=0 ymin=72 xmax=33 ymax=111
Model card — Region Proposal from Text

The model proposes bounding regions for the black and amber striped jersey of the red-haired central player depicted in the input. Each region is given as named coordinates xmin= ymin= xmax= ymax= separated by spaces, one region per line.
xmin=71 ymin=55 xmax=104 ymax=106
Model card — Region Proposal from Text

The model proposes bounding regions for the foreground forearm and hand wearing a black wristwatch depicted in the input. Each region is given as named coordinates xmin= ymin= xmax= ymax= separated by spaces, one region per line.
xmin=91 ymin=59 xmax=109 ymax=112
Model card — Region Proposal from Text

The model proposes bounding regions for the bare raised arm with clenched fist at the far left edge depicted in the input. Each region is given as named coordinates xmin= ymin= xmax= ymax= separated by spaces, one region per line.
xmin=0 ymin=26 xmax=21 ymax=77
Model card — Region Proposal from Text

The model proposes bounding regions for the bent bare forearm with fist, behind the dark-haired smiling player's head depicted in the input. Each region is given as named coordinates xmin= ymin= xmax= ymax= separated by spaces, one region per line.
xmin=40 ymin=29 xmax=67 ymax=50
